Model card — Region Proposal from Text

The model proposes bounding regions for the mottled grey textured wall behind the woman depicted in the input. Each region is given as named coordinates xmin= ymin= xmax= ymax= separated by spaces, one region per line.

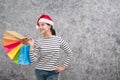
xmin=0 ymin=0 xmax=120 ymax=80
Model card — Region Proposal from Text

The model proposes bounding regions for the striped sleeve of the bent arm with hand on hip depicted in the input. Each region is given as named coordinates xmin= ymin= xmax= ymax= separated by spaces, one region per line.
xmin=60 ymin=39 xmax=73 ymax=68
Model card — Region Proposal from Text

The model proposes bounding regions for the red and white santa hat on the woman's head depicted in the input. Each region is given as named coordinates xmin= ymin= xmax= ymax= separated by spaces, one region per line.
xmin=36 ymin=14 xmax=54 ymax=29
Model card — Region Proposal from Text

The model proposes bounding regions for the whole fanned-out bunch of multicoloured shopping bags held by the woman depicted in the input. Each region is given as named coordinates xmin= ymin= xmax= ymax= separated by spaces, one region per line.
xmin=3 ymin=30 xmax=30 ymax=65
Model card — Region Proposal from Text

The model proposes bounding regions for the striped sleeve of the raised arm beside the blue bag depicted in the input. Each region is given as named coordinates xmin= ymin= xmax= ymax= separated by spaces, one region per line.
xmin=29 ymin=40 xmax=40 ymax=63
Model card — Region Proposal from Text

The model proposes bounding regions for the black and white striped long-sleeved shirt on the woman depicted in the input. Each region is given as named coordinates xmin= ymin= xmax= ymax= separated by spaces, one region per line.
xmin=30 ymin=36 xmax=73 ymax=71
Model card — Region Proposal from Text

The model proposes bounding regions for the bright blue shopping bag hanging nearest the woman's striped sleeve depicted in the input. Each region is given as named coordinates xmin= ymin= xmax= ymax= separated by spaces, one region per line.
xmin=18 ymin=44 xmax=31 ymax=65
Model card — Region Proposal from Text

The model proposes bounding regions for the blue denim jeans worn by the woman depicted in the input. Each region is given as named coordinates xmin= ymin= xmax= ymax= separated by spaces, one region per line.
xmin=35 ymin=69 xmax=59 ymax=80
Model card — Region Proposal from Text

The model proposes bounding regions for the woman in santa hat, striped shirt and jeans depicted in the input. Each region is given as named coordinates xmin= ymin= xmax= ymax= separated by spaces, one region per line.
xmin=29 ymin=14 xmax=72 ymax=80
